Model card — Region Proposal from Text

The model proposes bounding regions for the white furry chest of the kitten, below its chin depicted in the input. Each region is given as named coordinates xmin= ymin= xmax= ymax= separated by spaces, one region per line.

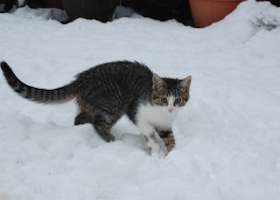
xmin=136 ymin=104 xmax=177 ymax=129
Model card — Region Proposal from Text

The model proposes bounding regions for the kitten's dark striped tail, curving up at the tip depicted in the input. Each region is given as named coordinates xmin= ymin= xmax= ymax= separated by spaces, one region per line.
xmin=1 ymin=62 xmax=78 ymax=103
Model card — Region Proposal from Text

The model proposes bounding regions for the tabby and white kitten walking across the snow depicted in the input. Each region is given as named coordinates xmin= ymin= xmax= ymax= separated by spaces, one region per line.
xmin=1 ymin=61 xmax=192 ymax=157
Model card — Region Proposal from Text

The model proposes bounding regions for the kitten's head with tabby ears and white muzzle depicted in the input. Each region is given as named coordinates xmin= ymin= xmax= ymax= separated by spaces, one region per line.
xmin=151 ymin=74 xmax=192 ymax=113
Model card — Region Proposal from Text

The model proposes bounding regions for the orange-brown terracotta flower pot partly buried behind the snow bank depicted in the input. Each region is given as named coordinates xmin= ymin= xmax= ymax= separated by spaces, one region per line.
xmin=190 ymin=0 xmax=244 ymax=27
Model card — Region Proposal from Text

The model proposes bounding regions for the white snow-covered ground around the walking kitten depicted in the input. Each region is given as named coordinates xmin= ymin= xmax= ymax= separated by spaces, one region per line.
xmin=0 ymin=0 xmax=280 ymax=200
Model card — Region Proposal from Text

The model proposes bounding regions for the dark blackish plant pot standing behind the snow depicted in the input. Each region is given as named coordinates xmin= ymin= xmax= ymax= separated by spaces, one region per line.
xmin=63 ymin=0 xmax=120 ymax=22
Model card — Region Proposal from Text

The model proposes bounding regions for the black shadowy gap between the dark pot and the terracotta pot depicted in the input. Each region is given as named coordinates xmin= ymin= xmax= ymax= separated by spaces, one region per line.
xmin=122 ymin=0 xmax=192 ymax=25
